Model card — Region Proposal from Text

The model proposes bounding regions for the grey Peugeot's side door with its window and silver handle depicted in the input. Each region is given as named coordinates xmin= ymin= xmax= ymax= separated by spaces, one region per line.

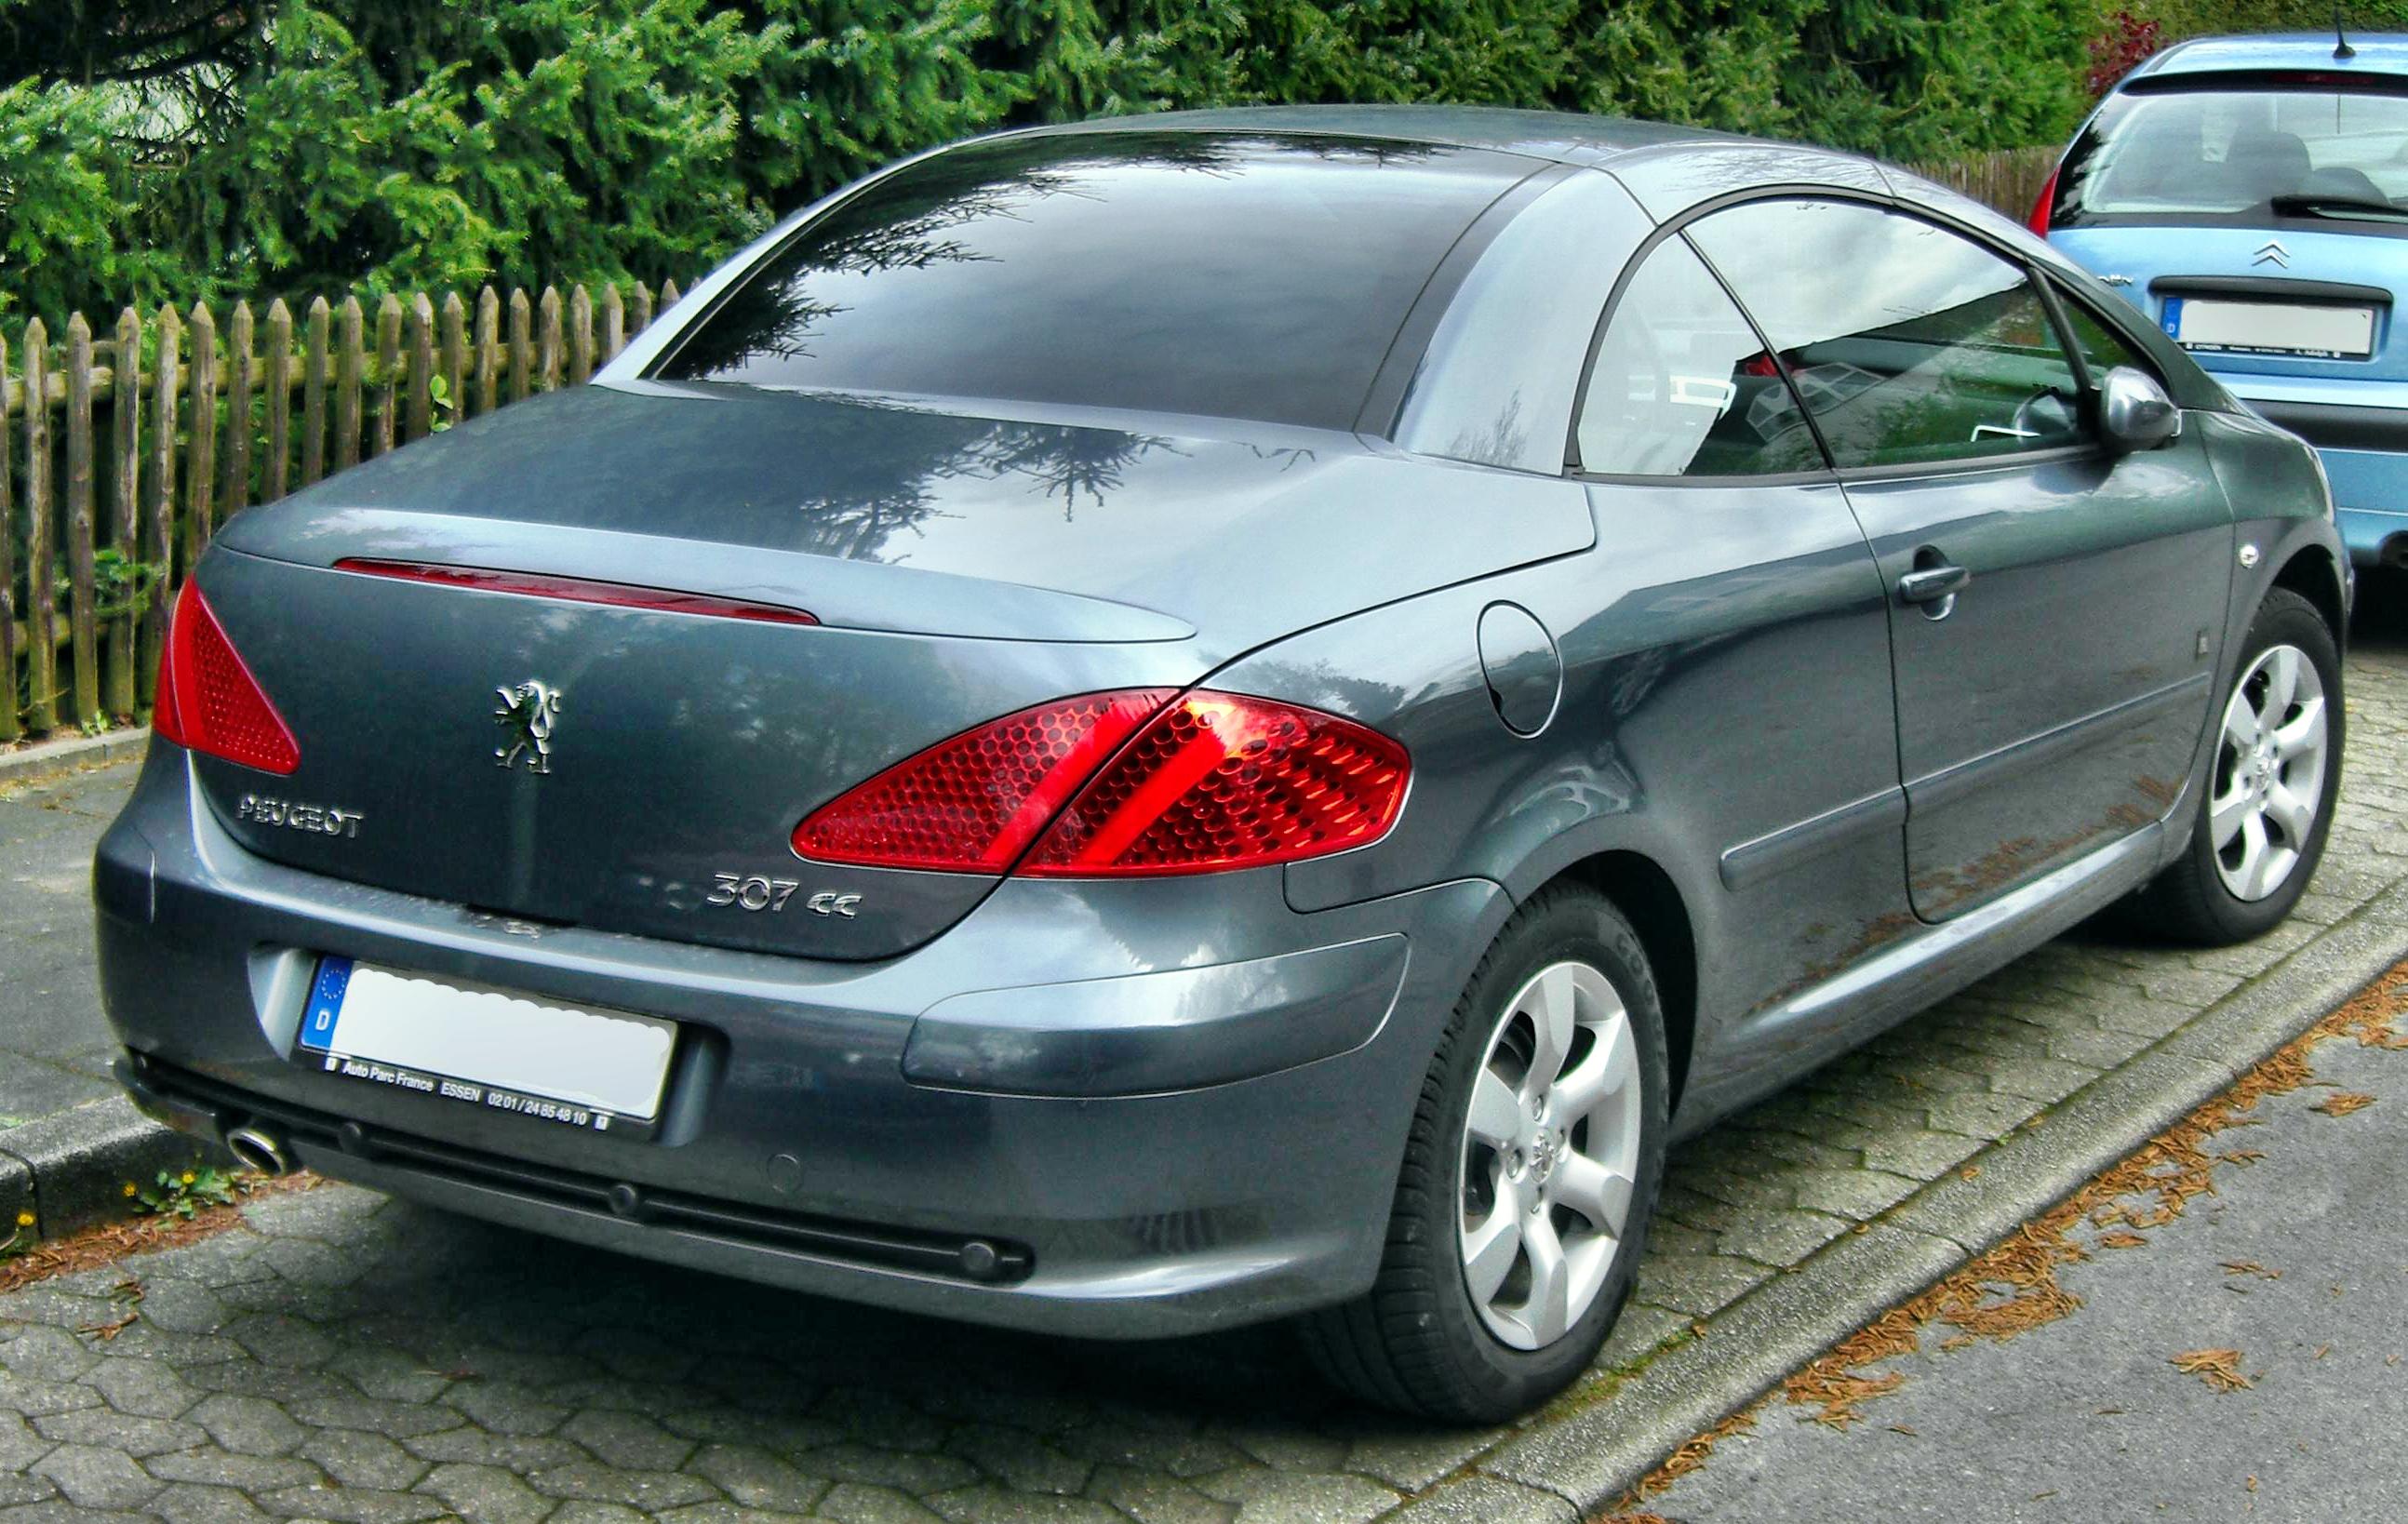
xmin=1691 ymin=197 xmax=2235 ymax=919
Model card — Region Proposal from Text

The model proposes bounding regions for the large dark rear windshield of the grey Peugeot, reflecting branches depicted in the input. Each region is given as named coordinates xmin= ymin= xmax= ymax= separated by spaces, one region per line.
xmin=655 ymin=130 xmax=1532 ymax=429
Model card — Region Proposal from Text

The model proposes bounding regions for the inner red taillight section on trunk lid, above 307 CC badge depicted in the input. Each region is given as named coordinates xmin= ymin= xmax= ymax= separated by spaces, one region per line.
xmin=795 ymin=688 xmax=1172 ymax=874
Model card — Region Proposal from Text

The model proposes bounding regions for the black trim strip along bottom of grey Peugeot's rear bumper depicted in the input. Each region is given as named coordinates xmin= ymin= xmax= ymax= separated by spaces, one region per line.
xmin=115 ymin=1054 xmax=1036 ymax=1286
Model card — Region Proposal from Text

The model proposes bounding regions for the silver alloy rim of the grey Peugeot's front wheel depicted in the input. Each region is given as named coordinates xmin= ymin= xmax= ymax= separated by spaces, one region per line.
xmin=2208 ymin=645 xmax=2329 ymax=901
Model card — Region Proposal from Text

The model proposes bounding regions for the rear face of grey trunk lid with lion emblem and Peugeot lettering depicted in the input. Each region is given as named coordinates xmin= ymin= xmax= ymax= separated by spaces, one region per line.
xmin=197 ymin=541 xmax=1199 ymax=958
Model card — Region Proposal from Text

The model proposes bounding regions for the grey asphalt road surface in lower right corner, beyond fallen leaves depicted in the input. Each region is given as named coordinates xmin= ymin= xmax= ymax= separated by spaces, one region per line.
xmin=1647 ymin=972 xmax=2408 ymax=1524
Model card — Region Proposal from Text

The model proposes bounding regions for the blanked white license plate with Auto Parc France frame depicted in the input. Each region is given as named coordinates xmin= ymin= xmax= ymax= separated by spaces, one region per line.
xmin=301 ymin=958 xmax=676 ymax=1136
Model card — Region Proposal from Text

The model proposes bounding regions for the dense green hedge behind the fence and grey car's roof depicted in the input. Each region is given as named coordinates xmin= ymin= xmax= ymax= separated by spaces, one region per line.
xmin=0 ymin=0 xmax=2100 ymax=318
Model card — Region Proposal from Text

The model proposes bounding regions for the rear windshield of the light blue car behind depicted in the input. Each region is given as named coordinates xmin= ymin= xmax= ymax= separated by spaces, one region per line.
xmin=2054 ymin=77 xmax=2408 ymax=231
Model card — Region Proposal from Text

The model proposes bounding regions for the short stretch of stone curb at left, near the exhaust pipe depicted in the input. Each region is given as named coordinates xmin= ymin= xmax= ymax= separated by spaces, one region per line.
xmin=0 ymin=1095 xmax=234 ymax=1237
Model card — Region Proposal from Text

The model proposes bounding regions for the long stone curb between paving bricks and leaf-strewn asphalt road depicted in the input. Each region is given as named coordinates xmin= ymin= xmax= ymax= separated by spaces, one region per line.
xmin=1387 ymin=879 xmax=2408 ymax=1524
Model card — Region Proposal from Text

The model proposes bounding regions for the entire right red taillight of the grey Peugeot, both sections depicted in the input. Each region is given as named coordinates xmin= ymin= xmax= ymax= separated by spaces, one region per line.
xmin=795 ymin=688 xmax=1409 ymax=879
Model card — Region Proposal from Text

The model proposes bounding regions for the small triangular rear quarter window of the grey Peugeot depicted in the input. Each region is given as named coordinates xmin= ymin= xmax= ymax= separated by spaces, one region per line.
xmin=1577 ymin=238 xmax=1823 ymax=476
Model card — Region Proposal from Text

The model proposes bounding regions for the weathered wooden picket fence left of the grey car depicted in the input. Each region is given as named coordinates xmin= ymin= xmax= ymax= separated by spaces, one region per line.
xmin=0 ymin=282 xmax=676 ymax=744
